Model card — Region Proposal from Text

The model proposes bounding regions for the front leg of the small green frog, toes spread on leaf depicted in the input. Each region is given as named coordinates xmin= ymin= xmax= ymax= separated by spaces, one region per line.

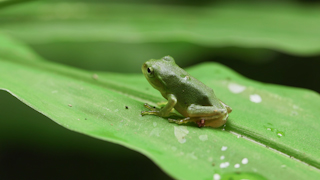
xmin=141 ymin=94 xmax=177 ymax=117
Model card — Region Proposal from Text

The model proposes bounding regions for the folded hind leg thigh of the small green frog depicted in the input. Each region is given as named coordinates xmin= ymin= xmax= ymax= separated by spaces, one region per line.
xmin=187 ymin=104 xmax=227 ymax=117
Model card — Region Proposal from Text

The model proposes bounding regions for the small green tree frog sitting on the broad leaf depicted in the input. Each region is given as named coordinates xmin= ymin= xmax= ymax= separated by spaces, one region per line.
xmin=141 ymin=56 xmax=232 ymax=127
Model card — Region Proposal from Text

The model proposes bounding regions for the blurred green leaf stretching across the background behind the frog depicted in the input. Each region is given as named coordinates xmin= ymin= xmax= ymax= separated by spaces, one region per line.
xmin=0 ymin=1 xmax=320 ymax=55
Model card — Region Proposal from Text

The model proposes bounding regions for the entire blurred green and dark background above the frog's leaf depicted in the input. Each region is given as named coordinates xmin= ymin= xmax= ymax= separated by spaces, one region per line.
xmin=0 ymin=0 xmax=320 ymax=92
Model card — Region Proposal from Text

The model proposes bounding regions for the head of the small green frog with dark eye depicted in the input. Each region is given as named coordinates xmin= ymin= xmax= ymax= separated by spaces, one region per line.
xmin=141 ymin=56 xmax=176 ymax=92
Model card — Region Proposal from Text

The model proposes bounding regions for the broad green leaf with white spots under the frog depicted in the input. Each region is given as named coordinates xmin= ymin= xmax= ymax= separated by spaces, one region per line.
xmin=0 ymin=34 xmax=320 ymax=180
